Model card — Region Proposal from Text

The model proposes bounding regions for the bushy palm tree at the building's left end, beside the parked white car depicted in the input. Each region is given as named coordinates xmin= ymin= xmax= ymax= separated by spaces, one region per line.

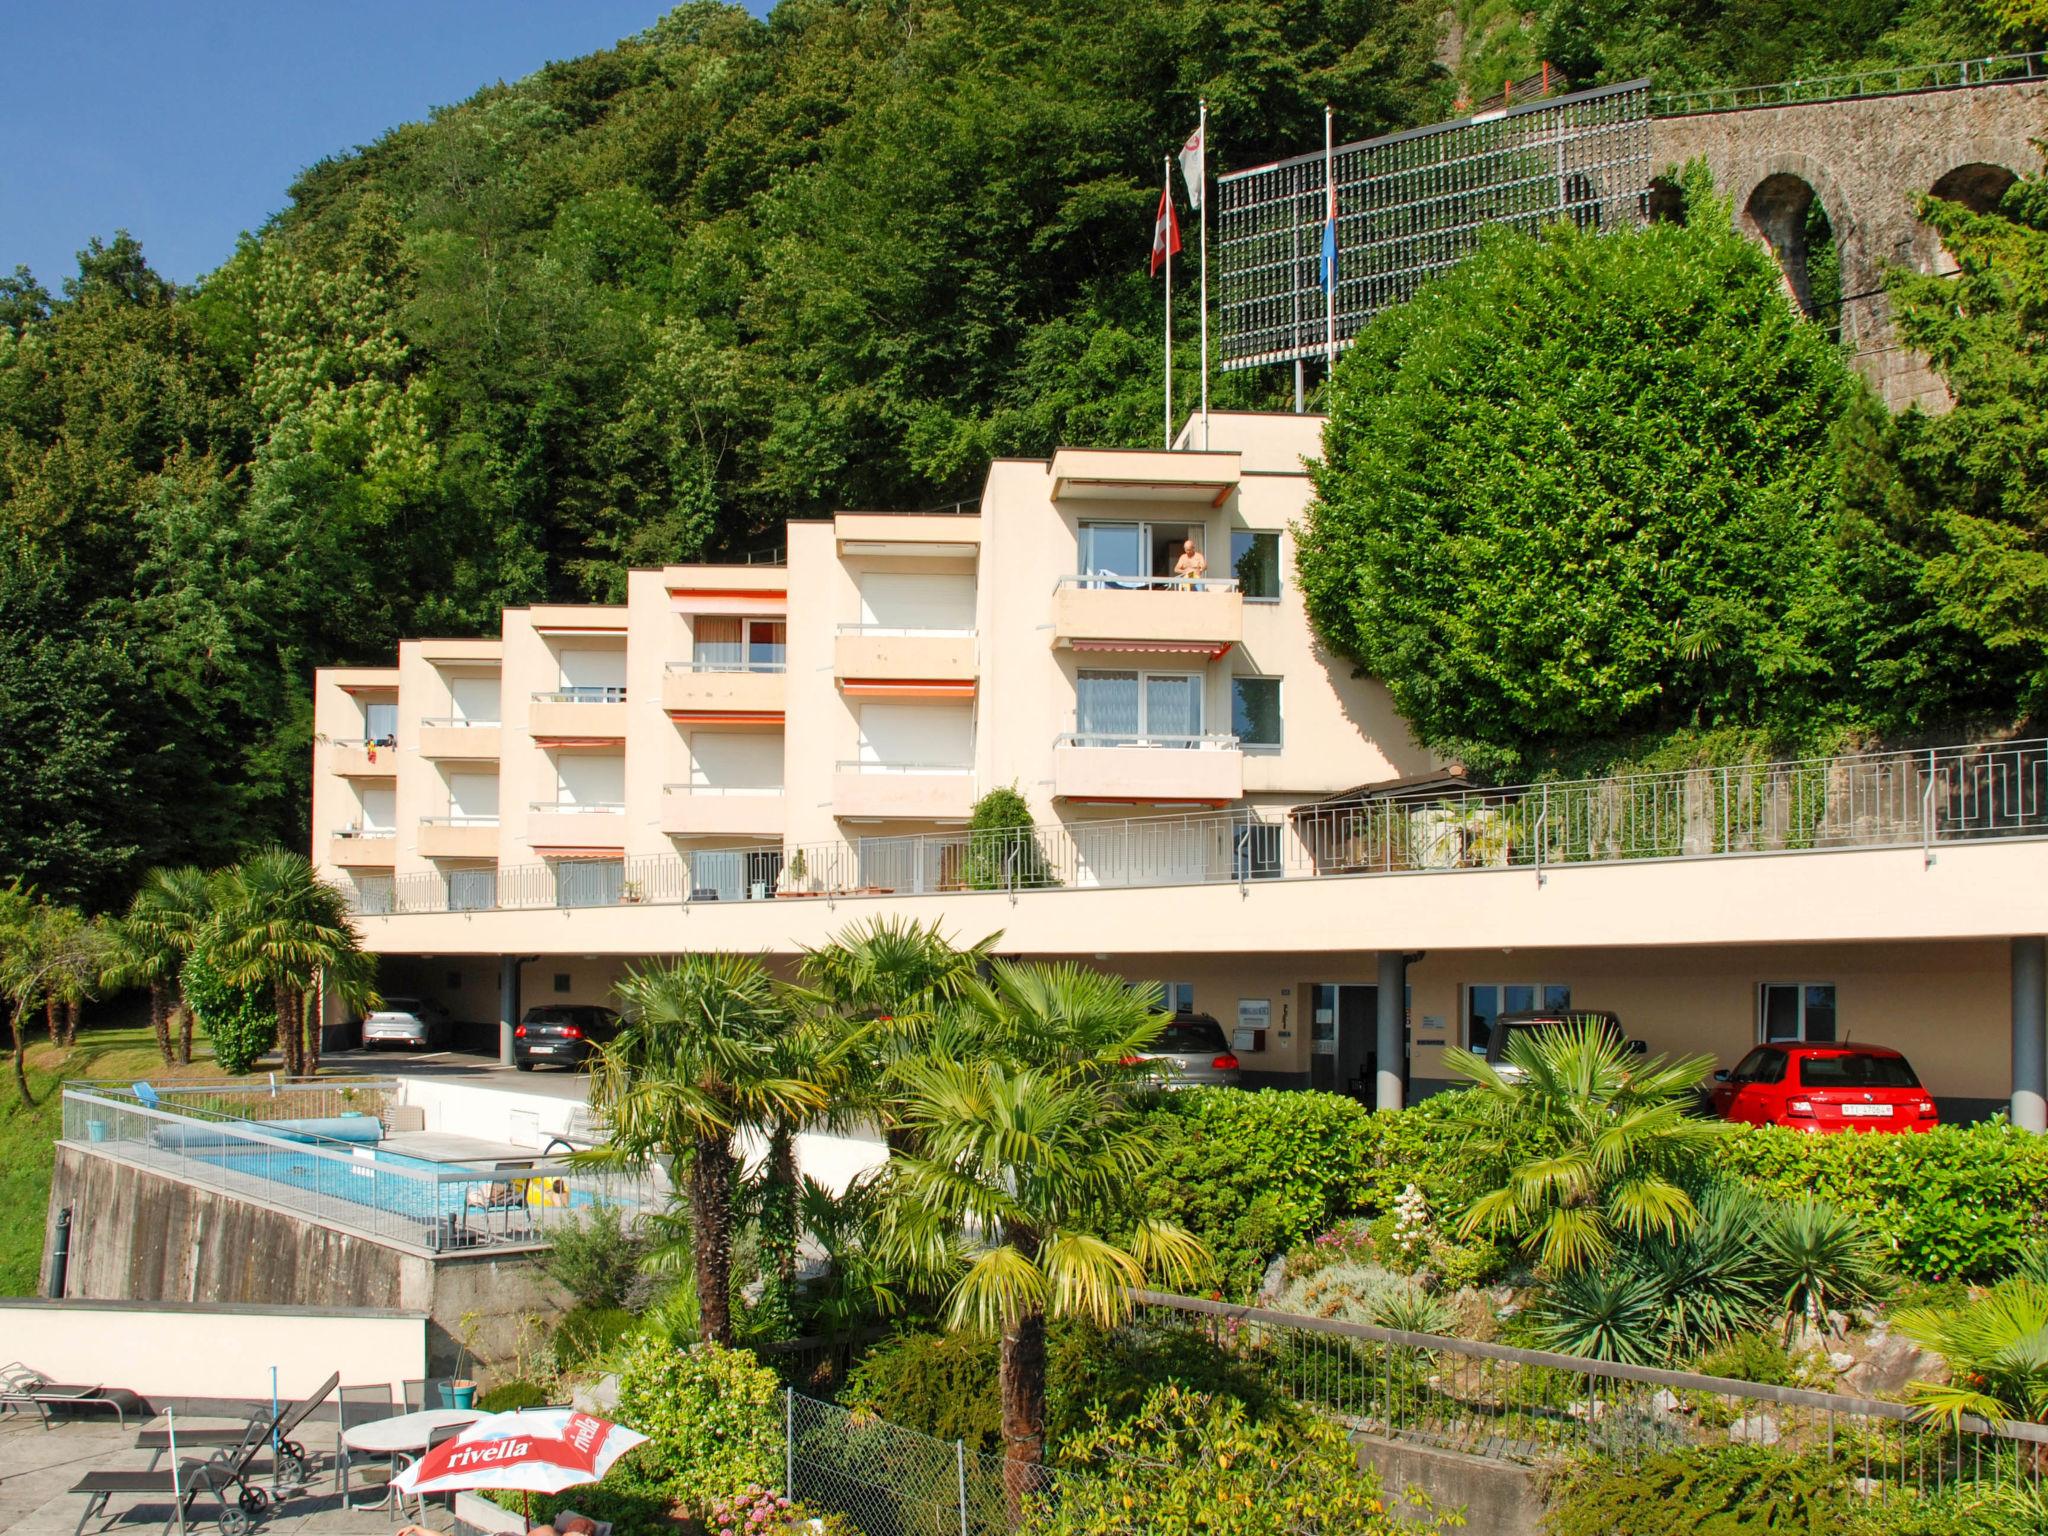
xmin=201 ymin=848 xmax=377 ymax=1075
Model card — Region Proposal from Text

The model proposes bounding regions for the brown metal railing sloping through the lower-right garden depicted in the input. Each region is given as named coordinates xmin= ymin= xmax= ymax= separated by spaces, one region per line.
xmin=1133 ymin=1290 xmax=2048 ymax=1501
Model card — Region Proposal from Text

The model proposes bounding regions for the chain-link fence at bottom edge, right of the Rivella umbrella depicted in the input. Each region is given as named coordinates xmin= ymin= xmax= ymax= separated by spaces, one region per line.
xmin=784 ymin=1391 xmax=1059 ymax=1536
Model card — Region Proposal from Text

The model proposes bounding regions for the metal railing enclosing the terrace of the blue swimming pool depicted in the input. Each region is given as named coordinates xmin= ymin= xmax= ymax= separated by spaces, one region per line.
xmin=63 ymin=1081 xmax=666 ymax=1253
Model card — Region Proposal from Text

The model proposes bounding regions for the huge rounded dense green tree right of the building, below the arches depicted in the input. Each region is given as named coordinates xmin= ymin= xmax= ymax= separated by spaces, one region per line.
xmin=1298 ymin=172 xmax=1862 ymax=772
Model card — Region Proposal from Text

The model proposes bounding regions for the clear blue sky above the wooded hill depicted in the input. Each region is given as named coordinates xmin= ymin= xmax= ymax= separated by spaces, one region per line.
xmin=0 ymin=0 xmax=770 ymax=291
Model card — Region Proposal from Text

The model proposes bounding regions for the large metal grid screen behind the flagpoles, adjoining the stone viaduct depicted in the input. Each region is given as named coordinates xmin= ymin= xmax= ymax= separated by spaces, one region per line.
xmin=1214 ymin=80 xmax=1651 ymax=369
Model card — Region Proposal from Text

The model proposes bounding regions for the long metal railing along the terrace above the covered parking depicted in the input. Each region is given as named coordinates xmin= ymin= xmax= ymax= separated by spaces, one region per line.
xmin=356 ymin=733 xmax=2048 ymax=913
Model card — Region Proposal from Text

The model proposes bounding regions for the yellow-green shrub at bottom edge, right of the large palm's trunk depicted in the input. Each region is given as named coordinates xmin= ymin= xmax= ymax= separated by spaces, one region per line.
xmin=1020 ymin=1386 xmax=1462 ymax=1536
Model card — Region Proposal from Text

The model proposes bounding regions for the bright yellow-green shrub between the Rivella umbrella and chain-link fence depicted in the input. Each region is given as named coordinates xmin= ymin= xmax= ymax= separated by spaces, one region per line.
xmin=608 ymin=1337 xmax=782 ymax=1511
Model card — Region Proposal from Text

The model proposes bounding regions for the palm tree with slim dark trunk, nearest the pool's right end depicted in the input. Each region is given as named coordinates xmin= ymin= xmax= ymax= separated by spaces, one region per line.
xmin=590 ymin=954 xmax=825 ymax=1346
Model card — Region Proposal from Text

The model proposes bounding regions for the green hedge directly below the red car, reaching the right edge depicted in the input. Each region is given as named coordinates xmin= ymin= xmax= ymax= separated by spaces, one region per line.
xmin=1712 ymin=1120 xmax=2048 ymax=1280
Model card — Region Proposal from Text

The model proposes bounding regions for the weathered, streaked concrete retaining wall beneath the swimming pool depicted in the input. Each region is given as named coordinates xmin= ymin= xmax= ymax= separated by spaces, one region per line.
xmin=43 ymin=1145 xmax=567 ymax=1376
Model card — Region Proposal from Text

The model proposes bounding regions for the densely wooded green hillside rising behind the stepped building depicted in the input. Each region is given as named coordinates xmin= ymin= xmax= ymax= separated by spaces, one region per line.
xmin=0 ymin=0 xmax=2032 ymax=909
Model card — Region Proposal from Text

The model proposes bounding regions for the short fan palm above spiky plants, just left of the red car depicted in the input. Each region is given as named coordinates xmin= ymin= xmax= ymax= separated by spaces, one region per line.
xmin=1444 ymin=1018 xmax=1720 ymax=1276
